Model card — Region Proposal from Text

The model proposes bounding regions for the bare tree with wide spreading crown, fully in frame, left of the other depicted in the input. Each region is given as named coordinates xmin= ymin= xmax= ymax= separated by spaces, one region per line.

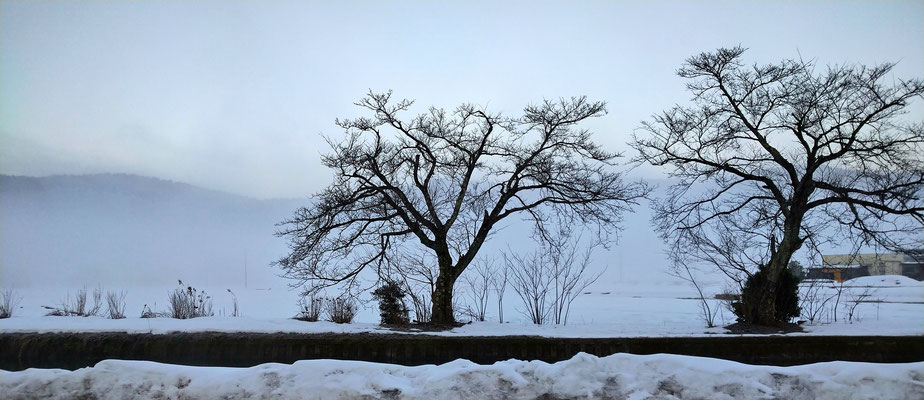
xmin=275 ymin=92 xmax=647 ymax=324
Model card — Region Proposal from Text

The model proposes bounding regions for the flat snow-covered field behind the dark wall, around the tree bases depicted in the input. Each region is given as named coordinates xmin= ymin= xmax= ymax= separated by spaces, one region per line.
xmin=0 ymin=276 xmax=924 ymax=337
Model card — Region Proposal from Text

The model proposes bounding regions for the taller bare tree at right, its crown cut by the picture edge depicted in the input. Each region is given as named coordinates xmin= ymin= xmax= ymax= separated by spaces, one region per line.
xmin=632 ymin=47 xmax=924 ymax=325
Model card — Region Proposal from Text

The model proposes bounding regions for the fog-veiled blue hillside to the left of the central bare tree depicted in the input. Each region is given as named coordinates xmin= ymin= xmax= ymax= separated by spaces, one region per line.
xmin=0 ymin=174 xmax=307 ymax=287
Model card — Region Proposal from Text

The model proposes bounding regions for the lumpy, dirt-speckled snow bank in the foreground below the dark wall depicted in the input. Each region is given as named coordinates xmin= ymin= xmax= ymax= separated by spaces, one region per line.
xmin=0 ymin=353 xmax=924 ymax=399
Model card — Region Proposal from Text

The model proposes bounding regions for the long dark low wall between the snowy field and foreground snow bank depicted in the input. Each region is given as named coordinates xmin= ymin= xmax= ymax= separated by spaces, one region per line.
xmin=0 ymin=332 xmax=924 ymax=371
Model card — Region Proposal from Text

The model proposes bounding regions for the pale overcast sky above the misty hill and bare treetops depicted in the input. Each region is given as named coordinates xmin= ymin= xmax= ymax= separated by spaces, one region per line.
xmin=0 ymin=1 xmax=924 ymax=198
